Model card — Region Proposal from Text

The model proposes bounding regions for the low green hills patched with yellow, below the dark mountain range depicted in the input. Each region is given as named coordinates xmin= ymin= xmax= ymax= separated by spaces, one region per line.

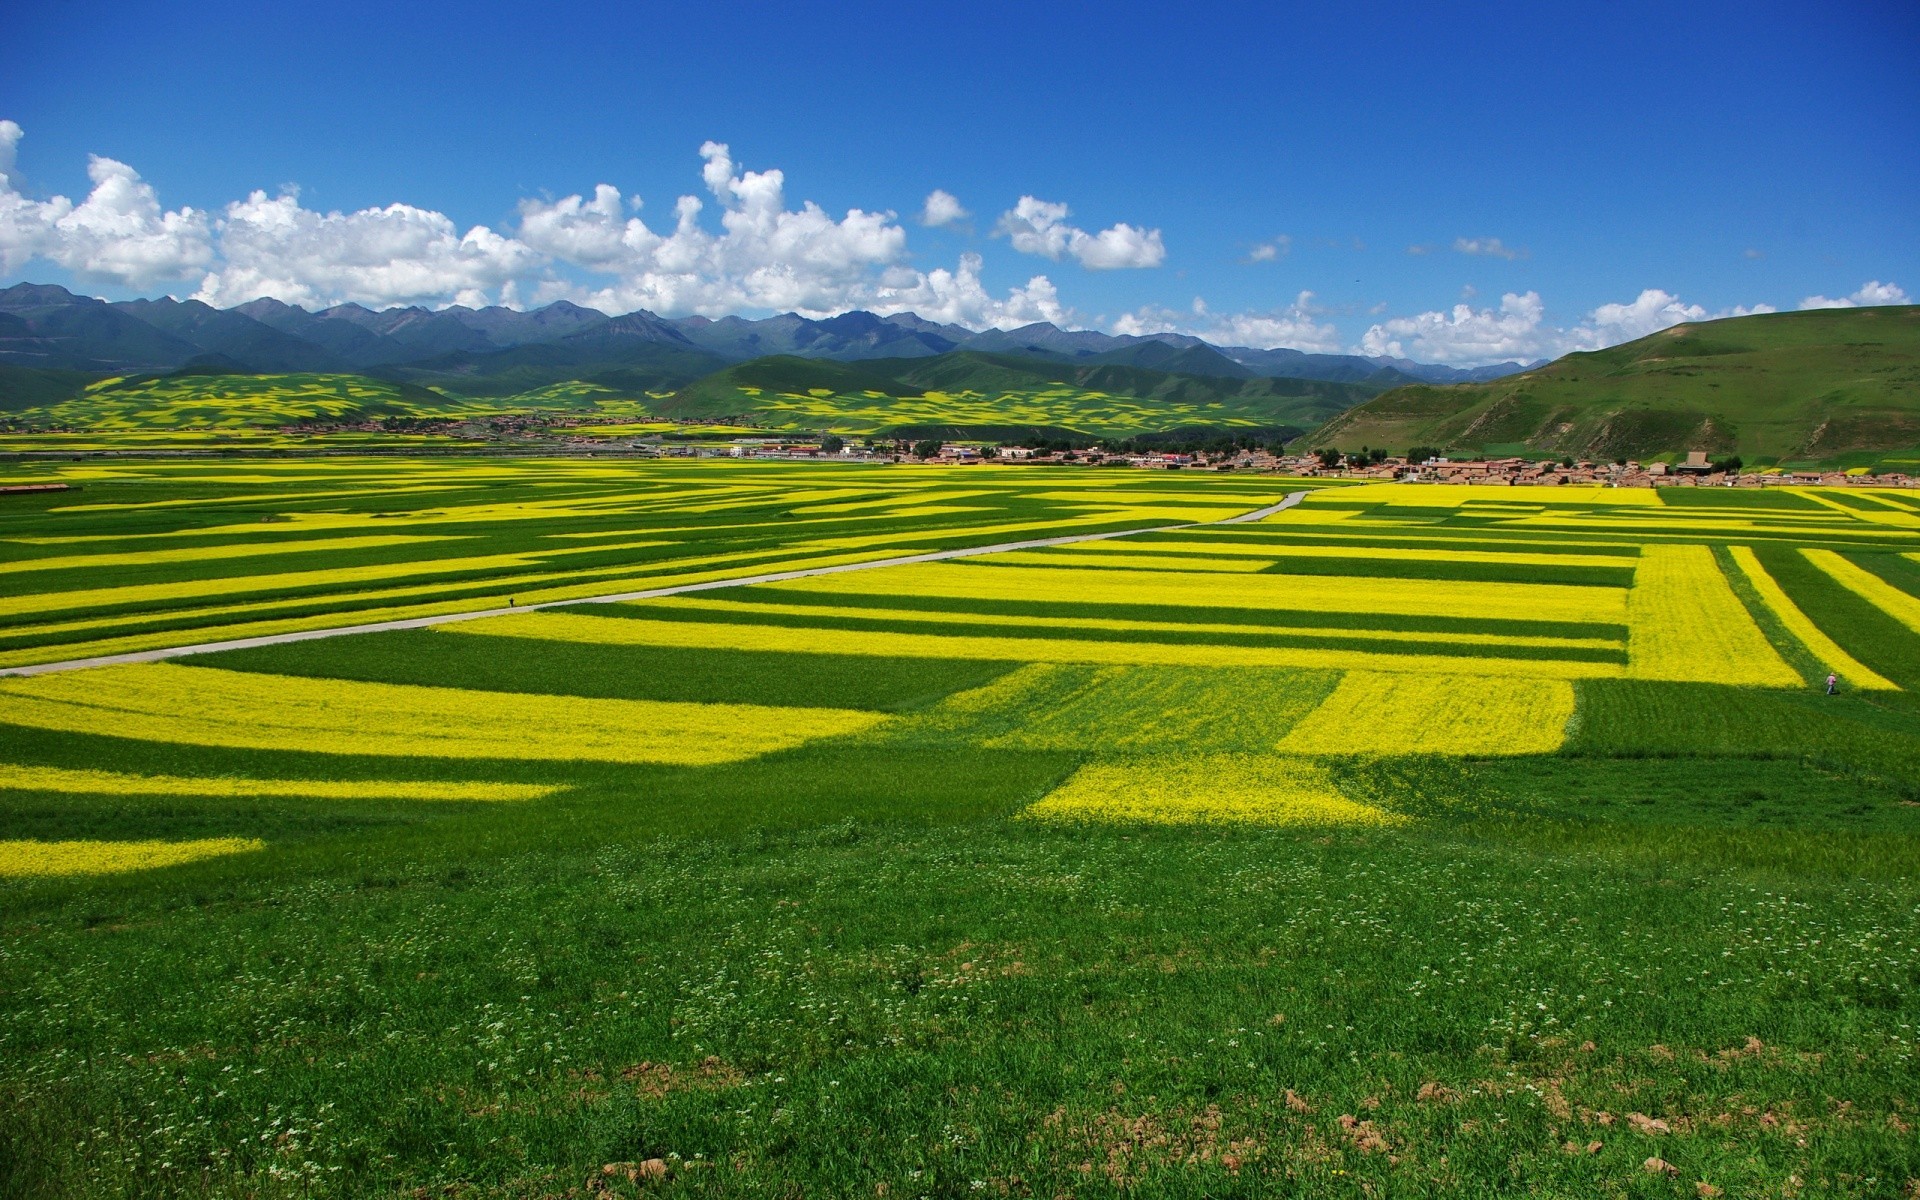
xmin=0 ymin=343 xmax=1377 ymax=440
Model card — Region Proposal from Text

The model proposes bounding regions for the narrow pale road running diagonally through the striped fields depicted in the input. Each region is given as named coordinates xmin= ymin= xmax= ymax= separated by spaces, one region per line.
xmin=0 ymin=492 xmax=1308 ymax=676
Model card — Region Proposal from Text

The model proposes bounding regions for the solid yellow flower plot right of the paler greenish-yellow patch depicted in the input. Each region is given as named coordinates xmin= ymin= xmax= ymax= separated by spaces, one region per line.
xmin=1281 ymin=670 xmax=1574 ymax=756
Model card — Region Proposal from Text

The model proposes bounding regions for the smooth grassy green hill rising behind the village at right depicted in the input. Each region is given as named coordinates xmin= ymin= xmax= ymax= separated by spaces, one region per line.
xmin=1313 ymin=305 xmax=1920 ymax=465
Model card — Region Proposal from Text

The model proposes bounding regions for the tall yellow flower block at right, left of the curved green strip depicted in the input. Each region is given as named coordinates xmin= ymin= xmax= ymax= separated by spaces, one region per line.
xmin=1626 ymin=543 xmax=1801 ymax=687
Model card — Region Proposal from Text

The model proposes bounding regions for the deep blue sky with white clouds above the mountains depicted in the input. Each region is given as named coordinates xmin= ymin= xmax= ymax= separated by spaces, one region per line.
xmin=0 ymin=0 xmax=1920 ymax=363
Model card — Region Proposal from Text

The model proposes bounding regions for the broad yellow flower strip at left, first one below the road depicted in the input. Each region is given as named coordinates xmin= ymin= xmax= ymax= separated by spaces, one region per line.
xmin=0 ymin=662 xmax=885 ymax=766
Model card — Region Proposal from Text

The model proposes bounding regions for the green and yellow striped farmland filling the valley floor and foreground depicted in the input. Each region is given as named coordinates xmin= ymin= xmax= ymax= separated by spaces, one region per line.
xmin=0 ymin=461 xmax=1920 ymax=1196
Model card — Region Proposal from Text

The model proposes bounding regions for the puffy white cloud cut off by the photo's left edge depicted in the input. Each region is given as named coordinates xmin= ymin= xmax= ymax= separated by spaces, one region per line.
xmin=0 ymin=121 xmax=213 ymax=288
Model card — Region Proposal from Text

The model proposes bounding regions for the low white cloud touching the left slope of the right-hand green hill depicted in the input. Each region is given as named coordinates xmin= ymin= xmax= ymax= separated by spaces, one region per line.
xmin=1356 ymin=288 xmax=1774 ymax=367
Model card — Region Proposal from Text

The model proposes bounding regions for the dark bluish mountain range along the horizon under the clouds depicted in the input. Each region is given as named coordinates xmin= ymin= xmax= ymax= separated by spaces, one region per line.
xmin=0 ymin=284 xmax=1526 ymax=411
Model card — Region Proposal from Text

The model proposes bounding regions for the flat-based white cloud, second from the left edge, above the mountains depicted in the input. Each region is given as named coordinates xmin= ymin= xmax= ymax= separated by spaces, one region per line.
xmin=196 ymin=192 xmax=540 ymax=307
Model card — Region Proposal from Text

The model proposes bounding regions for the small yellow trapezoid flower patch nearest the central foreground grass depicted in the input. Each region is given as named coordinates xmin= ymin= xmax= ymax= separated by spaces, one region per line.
xmin=1025 ymin=755 xmax=1405 ymax=826
